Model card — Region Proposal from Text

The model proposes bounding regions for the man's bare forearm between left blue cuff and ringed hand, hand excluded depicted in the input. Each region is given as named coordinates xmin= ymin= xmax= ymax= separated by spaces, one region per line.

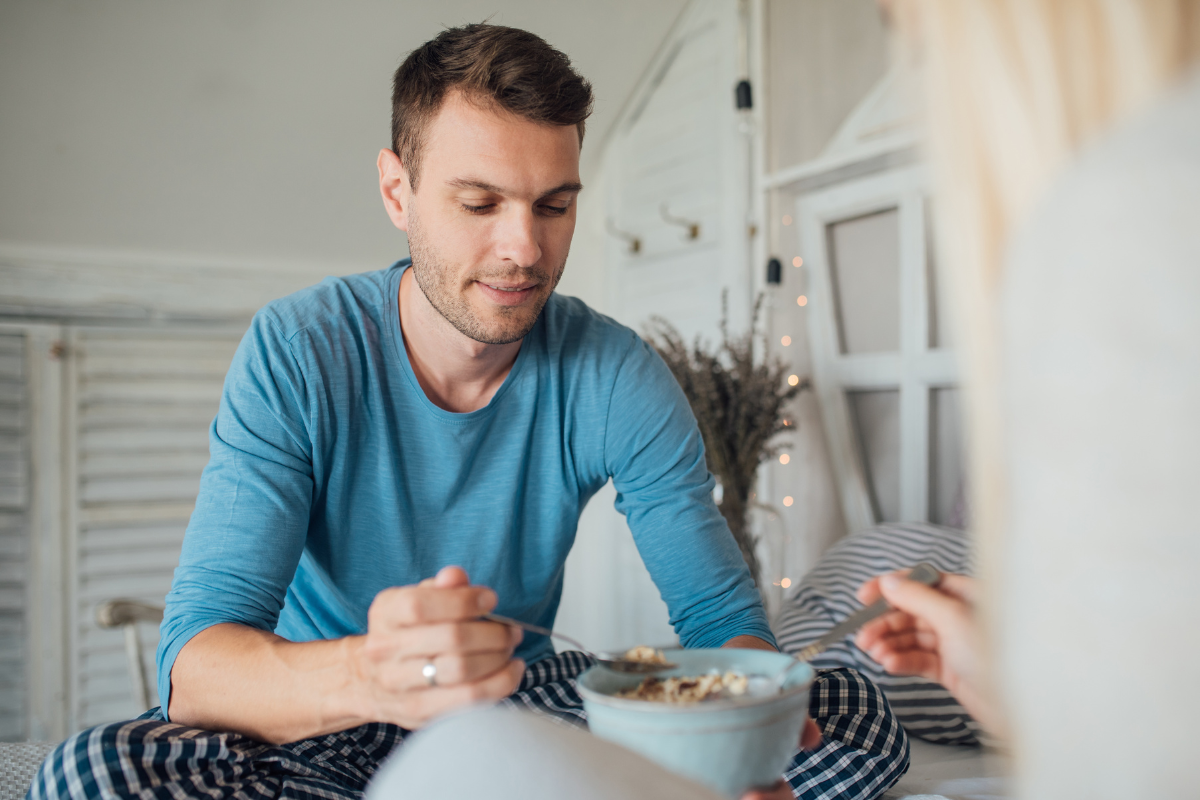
xmin=169 ymin=622 xmax=371 ymax=744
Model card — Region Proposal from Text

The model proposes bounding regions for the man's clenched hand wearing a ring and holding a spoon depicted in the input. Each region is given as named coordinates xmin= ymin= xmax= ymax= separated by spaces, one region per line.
xmin=352 ymin=566 xmax=524 ymax=730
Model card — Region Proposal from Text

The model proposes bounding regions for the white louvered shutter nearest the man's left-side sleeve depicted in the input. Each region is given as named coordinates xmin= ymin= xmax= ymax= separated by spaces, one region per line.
xmin=71 ymin=329 xmax=241 ymax=728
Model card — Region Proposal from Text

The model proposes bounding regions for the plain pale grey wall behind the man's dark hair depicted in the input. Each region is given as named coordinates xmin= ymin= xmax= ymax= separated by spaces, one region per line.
xmin=0 ymin=0 xmax=684 ymax=271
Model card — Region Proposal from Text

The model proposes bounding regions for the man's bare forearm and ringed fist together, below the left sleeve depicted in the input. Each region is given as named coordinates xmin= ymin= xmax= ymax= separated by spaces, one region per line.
xmin=169 ymin=567 xmax=524 ymax=744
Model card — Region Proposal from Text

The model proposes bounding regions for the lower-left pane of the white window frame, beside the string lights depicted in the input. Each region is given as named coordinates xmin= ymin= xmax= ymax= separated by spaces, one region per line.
xmin=846 ymin=389 xmax=900 ymax=522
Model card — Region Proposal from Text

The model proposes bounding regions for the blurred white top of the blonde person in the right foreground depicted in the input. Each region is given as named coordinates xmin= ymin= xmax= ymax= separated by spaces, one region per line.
xmin=998 ymin=68 xmax=1200 ymax=799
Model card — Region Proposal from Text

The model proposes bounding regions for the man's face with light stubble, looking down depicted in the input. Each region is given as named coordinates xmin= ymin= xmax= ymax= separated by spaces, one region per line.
xmin=397 ymin=94 xmax=581 ymax=344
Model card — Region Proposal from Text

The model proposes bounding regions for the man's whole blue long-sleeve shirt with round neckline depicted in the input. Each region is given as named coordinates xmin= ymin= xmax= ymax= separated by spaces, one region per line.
xmin=157 ymin=260 xmax=774 ymax=710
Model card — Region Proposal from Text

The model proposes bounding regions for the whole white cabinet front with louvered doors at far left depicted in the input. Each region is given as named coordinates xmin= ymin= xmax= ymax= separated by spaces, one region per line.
xmin=0 ymin=324 xmax=242 ymax=740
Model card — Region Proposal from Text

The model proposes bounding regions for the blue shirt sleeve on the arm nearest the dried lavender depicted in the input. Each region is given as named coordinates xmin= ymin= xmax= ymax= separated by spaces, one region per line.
xmin=605 ymin=338 xmax=775 ymax=648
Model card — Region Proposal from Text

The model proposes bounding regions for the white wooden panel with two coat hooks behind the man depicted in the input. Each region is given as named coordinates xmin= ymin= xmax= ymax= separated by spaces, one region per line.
xmin=557 ymin=0 xmax=750 ymax=648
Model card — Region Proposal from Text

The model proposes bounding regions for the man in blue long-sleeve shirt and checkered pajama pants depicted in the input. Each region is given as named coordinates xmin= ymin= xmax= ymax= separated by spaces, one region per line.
xmin=34 ymin=25 xmax=902 ymax=796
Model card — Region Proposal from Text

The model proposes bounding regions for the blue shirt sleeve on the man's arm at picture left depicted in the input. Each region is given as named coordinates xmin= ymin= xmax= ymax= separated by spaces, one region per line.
xmin=157 ymin=312 xmax=313 ymax=716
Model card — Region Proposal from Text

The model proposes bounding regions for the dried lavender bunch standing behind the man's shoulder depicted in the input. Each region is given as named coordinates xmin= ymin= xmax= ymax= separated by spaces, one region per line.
xmin=647 ymin=293 xmax=809 ymax=584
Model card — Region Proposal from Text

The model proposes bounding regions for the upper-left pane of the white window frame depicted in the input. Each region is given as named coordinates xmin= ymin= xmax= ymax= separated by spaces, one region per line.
xmin=828 ymin=209 xmax=900 ymax=353
